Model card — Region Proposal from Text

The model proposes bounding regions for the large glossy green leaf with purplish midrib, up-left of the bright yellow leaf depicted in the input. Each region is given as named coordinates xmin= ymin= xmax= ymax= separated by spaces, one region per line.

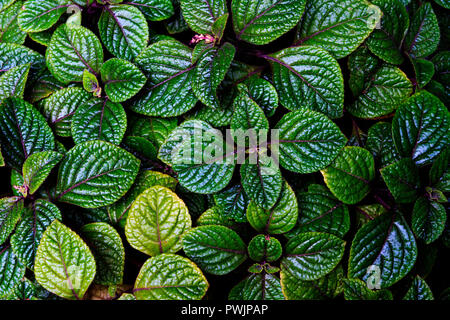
xmin=56 ymin=140 xmax=140 ymax=208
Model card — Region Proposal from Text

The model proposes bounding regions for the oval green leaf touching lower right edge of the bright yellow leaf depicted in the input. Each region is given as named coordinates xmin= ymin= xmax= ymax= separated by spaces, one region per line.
xmin=183 ymin=226 xmax=247 ymax=275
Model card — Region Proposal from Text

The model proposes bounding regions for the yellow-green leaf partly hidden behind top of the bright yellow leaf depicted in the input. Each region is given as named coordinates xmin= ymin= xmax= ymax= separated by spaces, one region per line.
xmin=108 ymin=170 xmax=178 ymax=228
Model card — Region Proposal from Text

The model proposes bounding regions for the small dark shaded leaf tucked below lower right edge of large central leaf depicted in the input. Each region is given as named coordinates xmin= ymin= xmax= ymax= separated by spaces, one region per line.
xmin=213 ymin=185 xmax=250 ymax=222
